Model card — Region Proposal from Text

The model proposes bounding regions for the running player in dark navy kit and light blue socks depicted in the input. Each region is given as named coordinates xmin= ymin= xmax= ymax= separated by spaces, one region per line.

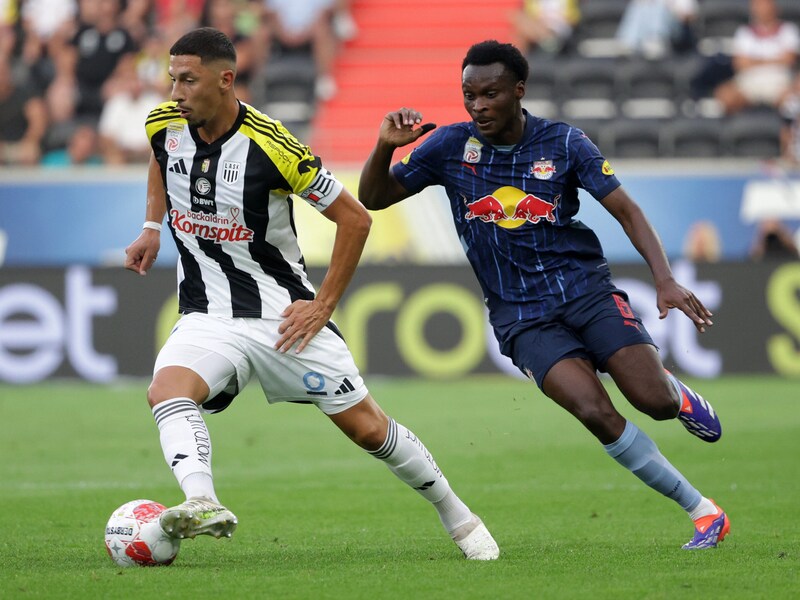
xmin=359 ymin=40 xmax=730 ymax=549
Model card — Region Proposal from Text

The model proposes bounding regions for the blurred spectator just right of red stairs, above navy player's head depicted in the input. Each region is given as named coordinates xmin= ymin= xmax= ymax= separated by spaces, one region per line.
xmin=511 ymin=0 xmax=580 ymax=54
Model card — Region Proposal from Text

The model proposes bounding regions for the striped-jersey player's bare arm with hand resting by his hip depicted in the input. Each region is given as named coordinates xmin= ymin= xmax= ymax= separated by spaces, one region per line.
xmin=275 ymin=189 xmax=372 ymax=352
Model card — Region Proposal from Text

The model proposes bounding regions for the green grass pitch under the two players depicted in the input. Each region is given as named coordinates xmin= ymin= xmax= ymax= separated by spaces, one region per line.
xmin=0 ymin=377 xmax=800 ymax=600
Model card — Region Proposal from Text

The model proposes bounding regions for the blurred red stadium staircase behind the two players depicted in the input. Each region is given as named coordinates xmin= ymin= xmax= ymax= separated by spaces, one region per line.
xmin=311 ymin=0 xmax=522 ymax=166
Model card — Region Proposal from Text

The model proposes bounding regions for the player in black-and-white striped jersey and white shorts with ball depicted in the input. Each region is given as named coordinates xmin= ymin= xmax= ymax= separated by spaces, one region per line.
xmin=125 ymin=28 xmax=499 ymax=560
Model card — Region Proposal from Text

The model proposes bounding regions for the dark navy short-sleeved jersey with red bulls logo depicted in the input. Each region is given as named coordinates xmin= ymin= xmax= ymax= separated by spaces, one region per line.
xmin=392 ymin=112 xmax=620 ymax=346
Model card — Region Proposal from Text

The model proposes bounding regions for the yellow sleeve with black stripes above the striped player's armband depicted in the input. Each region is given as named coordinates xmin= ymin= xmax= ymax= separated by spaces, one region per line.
xmin=239 ymin=106 xmax=320 ymax=192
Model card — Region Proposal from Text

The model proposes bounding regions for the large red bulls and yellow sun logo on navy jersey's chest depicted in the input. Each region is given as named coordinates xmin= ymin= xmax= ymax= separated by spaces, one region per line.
xmin=464 ymin=186 xmax=561 ymax=229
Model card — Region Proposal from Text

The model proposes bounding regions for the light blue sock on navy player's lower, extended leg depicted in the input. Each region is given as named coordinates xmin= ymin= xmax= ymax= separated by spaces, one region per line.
xmin=603 ymin=421 xmax=702 ymax=511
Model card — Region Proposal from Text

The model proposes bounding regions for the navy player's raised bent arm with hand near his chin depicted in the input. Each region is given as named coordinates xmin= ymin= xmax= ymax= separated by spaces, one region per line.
xmin=358 ymin=108 xmax=436 ymax=210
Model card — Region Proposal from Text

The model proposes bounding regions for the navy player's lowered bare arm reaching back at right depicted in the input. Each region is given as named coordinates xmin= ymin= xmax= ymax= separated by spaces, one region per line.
xmin=600 ymin=187 xmax=713 ymax=333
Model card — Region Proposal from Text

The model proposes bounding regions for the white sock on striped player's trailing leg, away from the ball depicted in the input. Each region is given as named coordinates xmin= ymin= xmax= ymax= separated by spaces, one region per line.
xmin=370 ymin=419 xmax=472 ymax=533
